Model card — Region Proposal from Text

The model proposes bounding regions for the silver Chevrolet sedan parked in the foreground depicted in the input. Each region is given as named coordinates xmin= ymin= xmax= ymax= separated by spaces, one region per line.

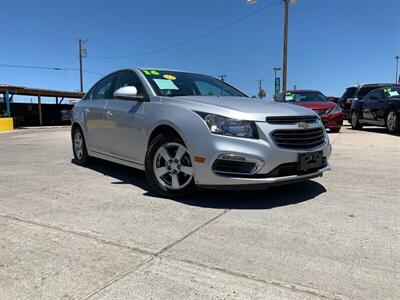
xmin=71 ymin=69 xmax=332 ymax=197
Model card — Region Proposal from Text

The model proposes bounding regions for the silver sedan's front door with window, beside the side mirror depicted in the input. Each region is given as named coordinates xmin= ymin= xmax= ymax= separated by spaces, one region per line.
xmin=104 ymin=70 xmax=148 ymax=164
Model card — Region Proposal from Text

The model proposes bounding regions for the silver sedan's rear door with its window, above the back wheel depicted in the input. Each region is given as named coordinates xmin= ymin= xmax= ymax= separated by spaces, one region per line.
xmin=83 ymin=74 xmax=116 ymax=153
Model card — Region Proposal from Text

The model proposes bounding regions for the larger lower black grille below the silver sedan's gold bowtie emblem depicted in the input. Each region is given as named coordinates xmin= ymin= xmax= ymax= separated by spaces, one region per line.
xmin=271 ymin=128 xmax=325 ymax=149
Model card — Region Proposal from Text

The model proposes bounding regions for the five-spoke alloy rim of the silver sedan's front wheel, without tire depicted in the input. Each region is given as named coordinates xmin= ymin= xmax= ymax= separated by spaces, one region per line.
xmin=153 ymin=143 xmax=193 ymax=190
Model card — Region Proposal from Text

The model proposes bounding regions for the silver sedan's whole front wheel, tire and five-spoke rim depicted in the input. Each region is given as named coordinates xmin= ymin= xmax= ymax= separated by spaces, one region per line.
xmin=145 ymin=134 xmax=196 ymax=198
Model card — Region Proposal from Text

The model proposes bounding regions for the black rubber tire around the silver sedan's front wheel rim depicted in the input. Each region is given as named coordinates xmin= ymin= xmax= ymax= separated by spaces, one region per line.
xmin=145 ymin=134 xmax=196 ymax=199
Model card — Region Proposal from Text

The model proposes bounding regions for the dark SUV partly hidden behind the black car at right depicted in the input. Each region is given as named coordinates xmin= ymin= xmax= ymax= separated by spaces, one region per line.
xmin=339 ymin=83 xmax=396 ymax=123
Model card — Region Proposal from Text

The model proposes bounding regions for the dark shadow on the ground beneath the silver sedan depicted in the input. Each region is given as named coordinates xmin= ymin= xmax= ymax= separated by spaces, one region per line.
xmin=71 ymin=159 xmax=326 ymax=209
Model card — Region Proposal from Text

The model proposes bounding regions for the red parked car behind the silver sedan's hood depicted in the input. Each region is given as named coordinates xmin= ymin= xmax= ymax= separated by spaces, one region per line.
xmin=276 ymin=90 xmax=343 ymax=132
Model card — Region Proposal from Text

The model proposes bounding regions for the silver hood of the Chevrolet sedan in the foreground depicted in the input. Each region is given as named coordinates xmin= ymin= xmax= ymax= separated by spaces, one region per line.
xmin=162 ymin=96 xmax=315 ymax=121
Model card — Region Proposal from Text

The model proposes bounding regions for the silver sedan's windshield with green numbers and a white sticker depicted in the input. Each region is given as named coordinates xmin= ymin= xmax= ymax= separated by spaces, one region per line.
xmin=142 ymin=69 xmax=247 ymax=97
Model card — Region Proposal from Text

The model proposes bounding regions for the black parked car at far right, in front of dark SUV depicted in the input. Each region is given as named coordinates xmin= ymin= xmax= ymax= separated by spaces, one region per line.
xmin=351 ymin=86 xmax=400 ymax=133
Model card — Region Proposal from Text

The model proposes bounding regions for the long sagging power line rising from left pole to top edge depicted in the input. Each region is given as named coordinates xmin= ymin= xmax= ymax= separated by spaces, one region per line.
xmin=88 ymin=1 xmax=280 ymax=59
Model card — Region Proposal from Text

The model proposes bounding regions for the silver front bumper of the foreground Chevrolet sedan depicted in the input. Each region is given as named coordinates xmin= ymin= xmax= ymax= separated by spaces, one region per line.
xmin=188 ymin=122 xmax=332 ymax=189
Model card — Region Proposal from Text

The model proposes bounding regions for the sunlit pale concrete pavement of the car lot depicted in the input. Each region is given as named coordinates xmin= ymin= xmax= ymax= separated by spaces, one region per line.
xmin=0 ymin=127 xmax=400 ymax=299
